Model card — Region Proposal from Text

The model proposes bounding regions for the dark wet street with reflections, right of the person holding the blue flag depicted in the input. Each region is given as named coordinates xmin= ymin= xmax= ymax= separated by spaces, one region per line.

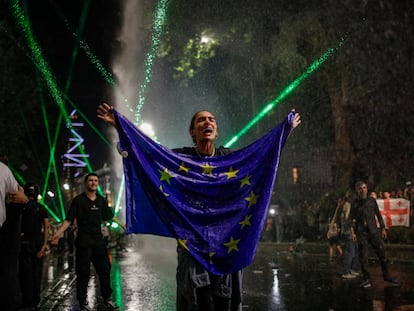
xmin=244 ymin=249 xmax=414 ymax=311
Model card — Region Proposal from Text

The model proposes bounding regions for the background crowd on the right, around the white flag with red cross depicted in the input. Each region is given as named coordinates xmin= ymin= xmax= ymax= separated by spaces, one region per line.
xmin=263 ymin=181 xmax=414 ymax=288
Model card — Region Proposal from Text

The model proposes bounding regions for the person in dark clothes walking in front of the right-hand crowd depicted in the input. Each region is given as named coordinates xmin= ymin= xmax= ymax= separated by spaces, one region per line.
xmin=351 ymin=181 xmax=399 ymax=288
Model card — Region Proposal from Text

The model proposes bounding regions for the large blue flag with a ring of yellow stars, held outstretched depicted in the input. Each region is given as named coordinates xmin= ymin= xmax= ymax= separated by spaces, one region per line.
xmin=114 ymin=111 xmax=294 ymax=275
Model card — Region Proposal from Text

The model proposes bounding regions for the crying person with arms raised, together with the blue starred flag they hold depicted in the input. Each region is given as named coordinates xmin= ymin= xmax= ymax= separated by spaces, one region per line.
xmin=98 ymin=103 xmax=301 ymax=311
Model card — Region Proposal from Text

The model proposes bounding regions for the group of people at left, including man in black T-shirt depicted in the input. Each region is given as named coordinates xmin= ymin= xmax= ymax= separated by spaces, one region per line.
xmin=0 ymin=162 xmax=123 ymax=311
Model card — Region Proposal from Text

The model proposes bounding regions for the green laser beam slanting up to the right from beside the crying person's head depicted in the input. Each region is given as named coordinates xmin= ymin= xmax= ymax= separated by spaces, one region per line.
xmin=224 ymin=37 xmax=345 ymax=148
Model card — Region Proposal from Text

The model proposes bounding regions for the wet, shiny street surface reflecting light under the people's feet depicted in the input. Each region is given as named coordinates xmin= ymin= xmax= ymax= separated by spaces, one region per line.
xmin=40 ymin=236 xmax=414 ymax=311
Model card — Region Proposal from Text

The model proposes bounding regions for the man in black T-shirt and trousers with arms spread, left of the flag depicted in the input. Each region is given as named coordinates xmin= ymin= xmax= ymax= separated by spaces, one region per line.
xmin=52 ymin=173 xmax=119 ymax=310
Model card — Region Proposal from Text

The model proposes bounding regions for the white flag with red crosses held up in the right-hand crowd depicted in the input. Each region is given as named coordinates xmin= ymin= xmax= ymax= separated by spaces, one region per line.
xmin=377 ymin=199 xmax=410 ymax=227
